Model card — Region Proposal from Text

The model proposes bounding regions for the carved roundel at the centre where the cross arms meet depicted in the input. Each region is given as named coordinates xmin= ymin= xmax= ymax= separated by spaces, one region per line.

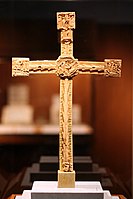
xmin=56 ymin=57 xmax=78 ymax=79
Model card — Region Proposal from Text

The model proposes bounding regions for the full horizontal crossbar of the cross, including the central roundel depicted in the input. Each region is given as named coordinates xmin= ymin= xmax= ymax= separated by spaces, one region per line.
xmin=12 ymin=56 xmax=122 ymax=79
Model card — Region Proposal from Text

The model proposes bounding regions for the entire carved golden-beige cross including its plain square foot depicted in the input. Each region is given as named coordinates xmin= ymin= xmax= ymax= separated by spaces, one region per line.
xmin=12 ymin=12 xmax=121 ymax=187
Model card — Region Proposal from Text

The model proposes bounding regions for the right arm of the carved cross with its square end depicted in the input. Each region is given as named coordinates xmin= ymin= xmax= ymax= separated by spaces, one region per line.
xmin=78 ymin=59 xmax=122 ymax=77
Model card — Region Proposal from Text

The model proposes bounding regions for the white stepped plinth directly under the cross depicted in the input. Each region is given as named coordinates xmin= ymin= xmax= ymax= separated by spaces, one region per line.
xmin=16 ymin=181 xmax=119 ymax=199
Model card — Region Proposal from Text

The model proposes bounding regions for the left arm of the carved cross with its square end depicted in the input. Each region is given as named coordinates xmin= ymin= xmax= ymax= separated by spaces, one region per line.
xmin=12 ymin=58 xmax=56 ymax=76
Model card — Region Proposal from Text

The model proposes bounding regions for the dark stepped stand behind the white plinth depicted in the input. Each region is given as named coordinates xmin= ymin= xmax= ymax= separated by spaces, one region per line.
xmin=21 ymin=156 xmax=113 ymax=190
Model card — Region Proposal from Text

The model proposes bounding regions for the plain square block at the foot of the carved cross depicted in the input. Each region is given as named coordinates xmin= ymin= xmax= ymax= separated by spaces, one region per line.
xmin=58 ymin=170 xmax=75 ymax=188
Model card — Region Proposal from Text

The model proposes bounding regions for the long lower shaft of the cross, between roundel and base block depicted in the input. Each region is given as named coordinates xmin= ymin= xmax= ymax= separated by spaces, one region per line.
xmin=60 ymin=79 xmax=73 ymax=172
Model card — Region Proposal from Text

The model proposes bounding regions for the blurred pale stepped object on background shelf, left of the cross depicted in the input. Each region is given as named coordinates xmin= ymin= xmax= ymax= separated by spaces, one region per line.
xmin=1 ymin=84 xmax=33 ymax=124
